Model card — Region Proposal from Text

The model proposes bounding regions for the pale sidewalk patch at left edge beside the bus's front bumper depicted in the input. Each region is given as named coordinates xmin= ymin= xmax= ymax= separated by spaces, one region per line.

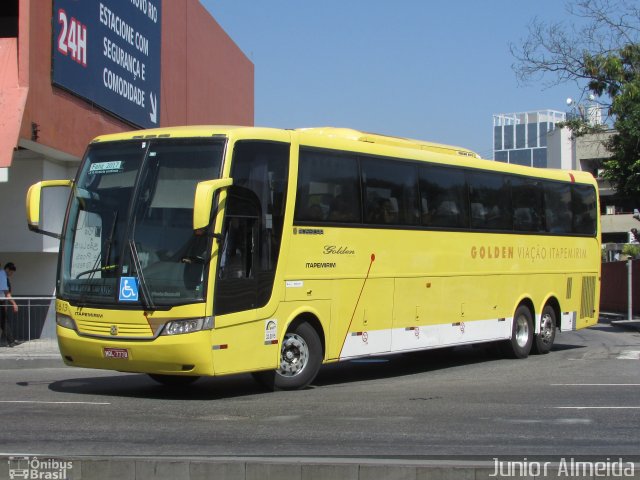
xmin=0 ymin=339 xmax=64 ymax=370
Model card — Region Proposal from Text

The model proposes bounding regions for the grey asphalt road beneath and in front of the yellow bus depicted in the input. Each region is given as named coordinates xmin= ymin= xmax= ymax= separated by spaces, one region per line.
xmin=0 ymin=325 xmax=640 ymax=458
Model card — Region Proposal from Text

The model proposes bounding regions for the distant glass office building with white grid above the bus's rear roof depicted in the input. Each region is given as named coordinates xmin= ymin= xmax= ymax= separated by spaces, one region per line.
xmin=493 ymin=110 xmax=566 ymax=168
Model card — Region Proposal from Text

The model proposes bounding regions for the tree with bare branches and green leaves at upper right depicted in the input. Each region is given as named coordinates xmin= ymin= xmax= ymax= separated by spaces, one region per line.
xmin=511 ymin=0 xmax=640 ymax=199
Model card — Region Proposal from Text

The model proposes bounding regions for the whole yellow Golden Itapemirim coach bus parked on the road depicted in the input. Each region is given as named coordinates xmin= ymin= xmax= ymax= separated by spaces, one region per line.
xmin=27 ymin=126 xmax=601 ymax=389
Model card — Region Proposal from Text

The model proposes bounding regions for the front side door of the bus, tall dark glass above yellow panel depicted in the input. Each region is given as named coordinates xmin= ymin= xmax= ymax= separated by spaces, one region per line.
xmin=212 ymin=140 xmax=290 ymax=374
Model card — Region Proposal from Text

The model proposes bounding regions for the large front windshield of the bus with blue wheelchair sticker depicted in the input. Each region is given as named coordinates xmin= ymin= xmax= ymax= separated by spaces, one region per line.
xmin=58 ymin=139 xmax=224 ymax=309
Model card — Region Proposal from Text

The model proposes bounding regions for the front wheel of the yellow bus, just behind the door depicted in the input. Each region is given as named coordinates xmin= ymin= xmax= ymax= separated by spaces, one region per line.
xmin=253 ymin=322 xmax=322 ymax=390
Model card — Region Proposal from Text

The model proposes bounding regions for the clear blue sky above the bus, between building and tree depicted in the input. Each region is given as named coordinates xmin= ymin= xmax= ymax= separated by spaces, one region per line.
xmin=201 ymin=0 xmax=581 ymax=158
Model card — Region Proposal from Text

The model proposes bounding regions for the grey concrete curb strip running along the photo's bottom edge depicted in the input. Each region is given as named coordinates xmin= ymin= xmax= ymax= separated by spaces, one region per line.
xmin=0 ymin=454 xmax=640 ymax=480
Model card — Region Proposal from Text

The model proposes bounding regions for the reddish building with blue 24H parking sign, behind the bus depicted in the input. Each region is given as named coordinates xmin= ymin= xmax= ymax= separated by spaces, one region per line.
xmin=0 ymin=0 xmax=254 ymax=295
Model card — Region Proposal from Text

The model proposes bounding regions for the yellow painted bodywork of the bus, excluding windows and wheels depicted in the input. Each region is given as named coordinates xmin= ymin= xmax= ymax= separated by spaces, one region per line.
xmin=50 ymin=126 xmax=600 ymax=375
